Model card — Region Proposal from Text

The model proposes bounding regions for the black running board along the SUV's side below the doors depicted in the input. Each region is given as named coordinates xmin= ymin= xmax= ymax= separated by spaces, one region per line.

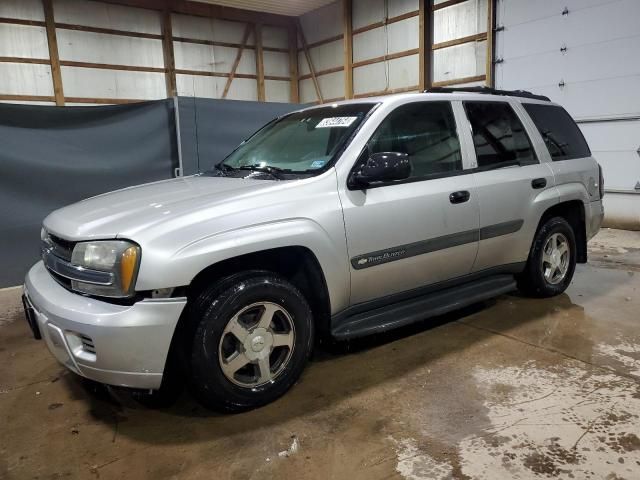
xmin=331 ymin=275 xmax=516 ymax=340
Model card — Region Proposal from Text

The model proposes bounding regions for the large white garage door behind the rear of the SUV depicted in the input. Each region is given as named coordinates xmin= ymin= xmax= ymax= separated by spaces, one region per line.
xmin=495 ymin=0 xmax=640 ymax=226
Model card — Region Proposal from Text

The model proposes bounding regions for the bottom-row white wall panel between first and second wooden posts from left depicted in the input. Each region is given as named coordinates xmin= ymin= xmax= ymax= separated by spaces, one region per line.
xmin=61 ymin=66 xmax=167 ymax=100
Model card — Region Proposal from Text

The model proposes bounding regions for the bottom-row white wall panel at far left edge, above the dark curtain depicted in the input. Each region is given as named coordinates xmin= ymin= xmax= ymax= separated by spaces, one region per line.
xmin=0 ymin=63 xmax=53 ymax=96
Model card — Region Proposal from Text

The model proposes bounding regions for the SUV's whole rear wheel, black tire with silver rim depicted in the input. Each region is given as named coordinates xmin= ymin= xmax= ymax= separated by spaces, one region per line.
xmin=518 ymin=217 xmax=577 ymax=298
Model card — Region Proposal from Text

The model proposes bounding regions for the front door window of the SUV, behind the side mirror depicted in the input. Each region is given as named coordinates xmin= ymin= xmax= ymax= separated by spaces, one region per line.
xmin=367 ymin=102 xmax=462 ymax=178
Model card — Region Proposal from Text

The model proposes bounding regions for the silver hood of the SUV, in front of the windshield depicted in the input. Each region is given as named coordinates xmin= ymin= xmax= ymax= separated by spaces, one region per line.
xmin=44 ymin=176 xmax=289 ymax=240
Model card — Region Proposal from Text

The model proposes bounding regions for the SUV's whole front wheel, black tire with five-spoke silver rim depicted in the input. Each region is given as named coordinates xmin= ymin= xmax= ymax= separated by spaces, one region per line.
xmin=189 ymin=271 xmax=314 ymax=412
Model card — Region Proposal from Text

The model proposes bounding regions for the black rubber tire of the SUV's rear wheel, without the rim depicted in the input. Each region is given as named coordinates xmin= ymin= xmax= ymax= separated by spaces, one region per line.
xmin=518 ymin=217 xmax=577 ymax=298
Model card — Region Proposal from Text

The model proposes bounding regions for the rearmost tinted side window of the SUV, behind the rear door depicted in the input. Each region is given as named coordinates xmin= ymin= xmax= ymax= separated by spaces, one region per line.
xmin=523 ymin=103 xmax=591 ymax=160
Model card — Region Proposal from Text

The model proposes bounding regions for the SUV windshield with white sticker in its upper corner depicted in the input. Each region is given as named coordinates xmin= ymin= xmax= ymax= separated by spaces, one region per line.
xmin=222 ymin=103 xmax=374 ymax=173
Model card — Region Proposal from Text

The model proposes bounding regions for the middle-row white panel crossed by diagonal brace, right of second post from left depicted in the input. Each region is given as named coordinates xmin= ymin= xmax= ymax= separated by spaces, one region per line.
xmin=173 ymin=42 xmax=256 ymax=75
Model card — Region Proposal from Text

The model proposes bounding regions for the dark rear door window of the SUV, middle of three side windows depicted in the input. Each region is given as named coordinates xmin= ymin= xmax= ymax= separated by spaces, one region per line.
xmin=464 ymin=102 xmax=538 ymax=169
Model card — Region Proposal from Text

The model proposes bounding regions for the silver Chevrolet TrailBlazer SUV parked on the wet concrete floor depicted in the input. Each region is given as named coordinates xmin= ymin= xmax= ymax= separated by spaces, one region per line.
xmin=24 ymin=89 xmax=603 ymax=411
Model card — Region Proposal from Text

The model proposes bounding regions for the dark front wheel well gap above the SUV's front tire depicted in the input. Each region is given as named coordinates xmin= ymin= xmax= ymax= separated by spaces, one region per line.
xmin=187 ymin=246 xmax=331 ymax=337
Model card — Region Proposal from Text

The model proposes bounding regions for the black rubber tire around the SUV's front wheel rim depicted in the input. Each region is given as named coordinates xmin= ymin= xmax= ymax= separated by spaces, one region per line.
xmin=189 ymin=271 xmax=314 ymax=412
